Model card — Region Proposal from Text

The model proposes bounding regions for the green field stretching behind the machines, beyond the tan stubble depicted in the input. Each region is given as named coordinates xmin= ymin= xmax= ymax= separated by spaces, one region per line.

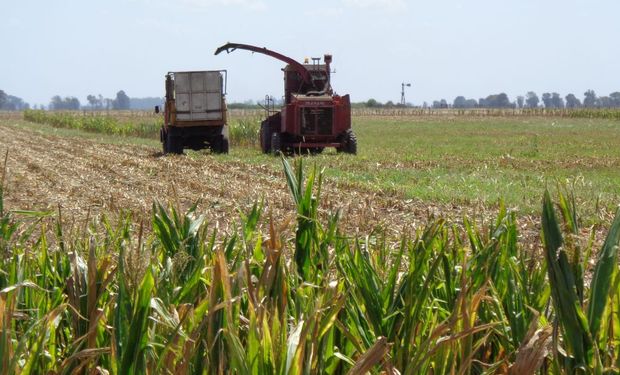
xmin=13 ymin=111 xmax=620 ymax=218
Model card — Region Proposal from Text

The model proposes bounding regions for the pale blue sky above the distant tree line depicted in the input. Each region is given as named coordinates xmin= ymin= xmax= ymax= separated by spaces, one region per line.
xmin=0 ymin=0 xmax=620 ymax=105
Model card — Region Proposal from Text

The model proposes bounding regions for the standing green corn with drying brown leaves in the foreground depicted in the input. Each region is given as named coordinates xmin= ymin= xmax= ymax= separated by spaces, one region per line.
xmin=0 ymin=159 xmax=620 ymax=374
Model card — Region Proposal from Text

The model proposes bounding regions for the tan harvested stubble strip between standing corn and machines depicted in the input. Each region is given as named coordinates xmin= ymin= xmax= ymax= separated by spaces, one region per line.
xmin=0 ymin=125 xmax=538 ymax=241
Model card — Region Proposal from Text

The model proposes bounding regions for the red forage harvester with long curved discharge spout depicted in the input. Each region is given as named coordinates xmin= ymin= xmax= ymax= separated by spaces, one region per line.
xmin=215 ymin=43 xmax=357 ymax=154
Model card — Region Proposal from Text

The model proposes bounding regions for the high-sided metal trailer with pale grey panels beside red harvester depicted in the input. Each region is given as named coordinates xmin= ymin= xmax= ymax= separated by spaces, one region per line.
xmin=155 ymin=70 xmax=228 ymax=154
